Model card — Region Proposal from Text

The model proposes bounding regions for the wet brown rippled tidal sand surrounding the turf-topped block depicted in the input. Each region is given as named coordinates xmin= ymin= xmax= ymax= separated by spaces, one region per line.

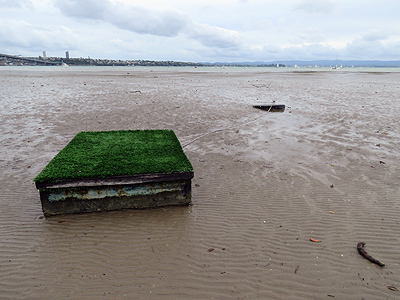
xmin=0 ymin=67 xmax=400 ymax=300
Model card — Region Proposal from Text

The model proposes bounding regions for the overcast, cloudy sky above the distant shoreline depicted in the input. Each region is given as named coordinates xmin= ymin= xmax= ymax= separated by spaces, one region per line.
xmin=0 ymin=0 xmax=400 ymax=62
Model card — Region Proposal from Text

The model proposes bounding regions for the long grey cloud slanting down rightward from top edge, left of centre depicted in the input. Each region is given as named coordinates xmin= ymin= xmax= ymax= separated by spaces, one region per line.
xmin=55 ymin=0 xmax=240 ymax=48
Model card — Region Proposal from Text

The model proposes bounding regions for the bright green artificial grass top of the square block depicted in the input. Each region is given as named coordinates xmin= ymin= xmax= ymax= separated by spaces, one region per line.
xmin=34 ymin=130 xmax=193 ymax=182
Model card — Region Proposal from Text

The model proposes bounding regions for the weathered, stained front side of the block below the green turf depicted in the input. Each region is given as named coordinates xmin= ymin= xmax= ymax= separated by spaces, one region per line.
xmin=39 ymin=174 xmax=193 ymax=217
